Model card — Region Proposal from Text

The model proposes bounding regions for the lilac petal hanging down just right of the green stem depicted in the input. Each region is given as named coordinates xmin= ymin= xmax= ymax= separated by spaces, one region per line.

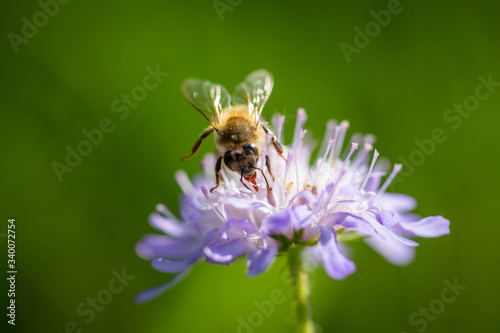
xmin=318 ymin=227 xmax=356 ymax=280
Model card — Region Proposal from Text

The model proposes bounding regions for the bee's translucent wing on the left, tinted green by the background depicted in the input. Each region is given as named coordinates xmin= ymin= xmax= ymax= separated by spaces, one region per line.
xmin=182 ymin=79 xmax=231 ymax=129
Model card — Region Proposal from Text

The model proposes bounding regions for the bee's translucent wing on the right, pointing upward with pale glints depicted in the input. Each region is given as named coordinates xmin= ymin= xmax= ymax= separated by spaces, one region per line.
xmin=233 ymin=69 xmax=274 ymax=125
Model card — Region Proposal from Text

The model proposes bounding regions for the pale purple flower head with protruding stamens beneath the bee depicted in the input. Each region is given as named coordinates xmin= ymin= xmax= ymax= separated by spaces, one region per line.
xmin=136 ymin=109 xmax=449 ymax=302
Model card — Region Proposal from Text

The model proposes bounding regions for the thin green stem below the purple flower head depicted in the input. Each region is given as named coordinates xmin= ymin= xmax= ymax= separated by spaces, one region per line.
xmin=288 ymin=247 xmax=314 ymax=333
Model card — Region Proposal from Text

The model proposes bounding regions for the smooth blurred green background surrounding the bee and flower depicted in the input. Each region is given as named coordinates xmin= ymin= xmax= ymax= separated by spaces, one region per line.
xmin=0 ymin=0 xmax=500 ymax=333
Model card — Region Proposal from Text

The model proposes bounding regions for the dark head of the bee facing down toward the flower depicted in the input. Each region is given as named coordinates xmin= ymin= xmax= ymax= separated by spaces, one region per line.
xmin=224 ymin=143 xmax=259 ymax=177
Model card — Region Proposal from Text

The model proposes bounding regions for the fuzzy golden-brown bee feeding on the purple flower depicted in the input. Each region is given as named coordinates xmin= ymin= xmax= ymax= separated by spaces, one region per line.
xmin=181 ymin=69 xmax=286 ymax=192
